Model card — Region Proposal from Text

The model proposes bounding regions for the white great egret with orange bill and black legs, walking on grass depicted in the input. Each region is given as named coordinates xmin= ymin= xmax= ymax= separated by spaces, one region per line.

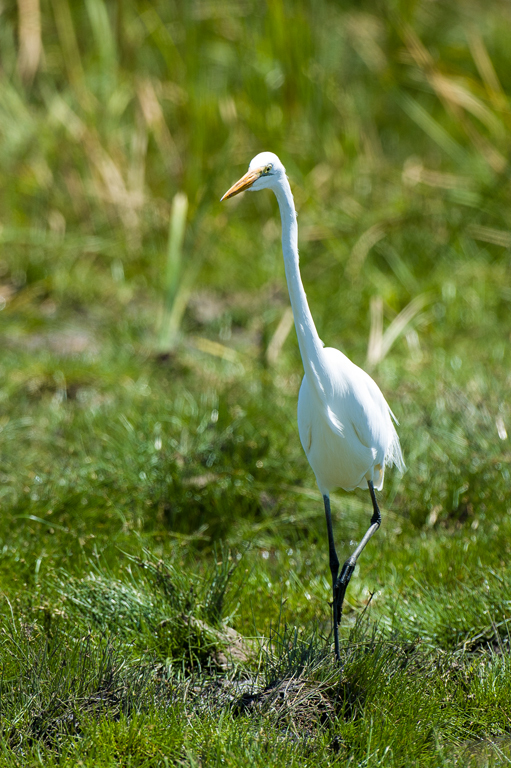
xmin=222 ymin=152 xmax=404 ymax=659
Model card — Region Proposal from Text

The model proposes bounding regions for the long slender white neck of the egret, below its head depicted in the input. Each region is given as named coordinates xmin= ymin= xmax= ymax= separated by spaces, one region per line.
xmin=275 ymin=177 xmax=323 ymax=391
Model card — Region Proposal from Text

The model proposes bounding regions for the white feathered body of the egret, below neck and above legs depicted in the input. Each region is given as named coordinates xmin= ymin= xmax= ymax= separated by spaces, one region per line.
xmin=298 ymin=348 xmax=404 ymax=493
